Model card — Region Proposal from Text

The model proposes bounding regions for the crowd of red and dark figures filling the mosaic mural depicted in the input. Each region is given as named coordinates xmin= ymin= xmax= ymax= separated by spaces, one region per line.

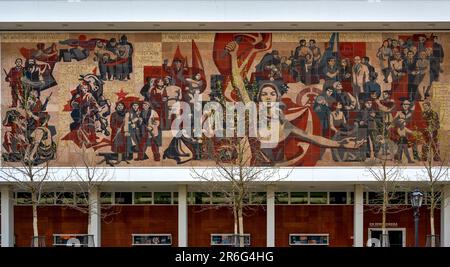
xmin=2 ymin=33 xmax=444 ymax=166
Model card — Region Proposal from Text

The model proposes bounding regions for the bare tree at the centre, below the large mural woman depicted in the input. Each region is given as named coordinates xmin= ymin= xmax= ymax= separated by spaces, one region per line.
xmin=191 ymin=137 xmax=291 ymax=247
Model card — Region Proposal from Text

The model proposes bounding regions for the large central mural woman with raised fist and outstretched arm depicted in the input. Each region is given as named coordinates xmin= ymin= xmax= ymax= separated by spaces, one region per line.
xmin=225 ymin=41 xmax=363 ymax=166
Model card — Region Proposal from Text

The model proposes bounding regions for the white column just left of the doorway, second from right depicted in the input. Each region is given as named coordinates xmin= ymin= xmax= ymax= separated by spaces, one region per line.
xmin=353 ymin=185 xmax=364 ymax=247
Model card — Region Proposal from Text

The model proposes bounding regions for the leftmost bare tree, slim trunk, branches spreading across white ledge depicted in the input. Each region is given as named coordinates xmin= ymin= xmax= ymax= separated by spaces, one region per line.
xmin=0 ymin=159 xmax=52 ymax=247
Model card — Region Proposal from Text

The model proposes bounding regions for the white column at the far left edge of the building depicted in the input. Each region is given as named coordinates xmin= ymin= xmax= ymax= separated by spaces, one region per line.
xmin=1 ymin=186 xmax=14 ymax=247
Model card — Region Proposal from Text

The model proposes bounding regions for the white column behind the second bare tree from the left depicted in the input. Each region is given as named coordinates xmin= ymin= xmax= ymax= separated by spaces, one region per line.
xmin=88 ymin=187 xmax=102 ymax=247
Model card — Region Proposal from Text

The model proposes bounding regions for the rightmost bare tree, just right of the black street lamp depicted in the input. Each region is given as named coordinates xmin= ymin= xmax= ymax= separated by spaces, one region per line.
xmin=418 ymin=101 xmax=450 ymax=247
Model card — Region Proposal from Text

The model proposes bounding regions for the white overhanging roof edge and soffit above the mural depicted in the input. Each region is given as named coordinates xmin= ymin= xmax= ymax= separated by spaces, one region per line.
xmin=0 ymin=0 xmax=450 ymax=31
